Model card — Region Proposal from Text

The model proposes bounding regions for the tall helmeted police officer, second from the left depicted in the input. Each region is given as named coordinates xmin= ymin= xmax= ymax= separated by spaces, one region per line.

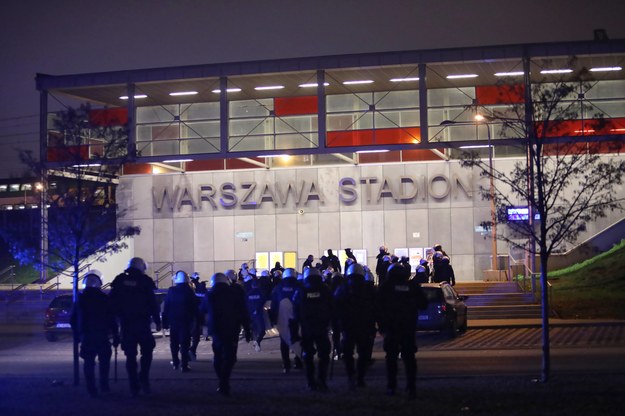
xmin=110 ymin=257 xmax=161 ymax=396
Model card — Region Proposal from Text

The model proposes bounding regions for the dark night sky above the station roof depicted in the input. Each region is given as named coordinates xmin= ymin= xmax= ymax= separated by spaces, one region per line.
xmin=0 ymin=0 xmax=625 ymax=177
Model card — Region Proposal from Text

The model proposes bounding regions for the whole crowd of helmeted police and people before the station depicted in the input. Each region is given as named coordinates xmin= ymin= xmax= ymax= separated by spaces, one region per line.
xmin=72 ymin=245 xmax=455 ymax=398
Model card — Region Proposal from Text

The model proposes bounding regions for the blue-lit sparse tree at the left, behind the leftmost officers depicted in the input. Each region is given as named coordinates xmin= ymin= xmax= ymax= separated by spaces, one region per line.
xmin=5 ymin=105 xmax=140 ymax=384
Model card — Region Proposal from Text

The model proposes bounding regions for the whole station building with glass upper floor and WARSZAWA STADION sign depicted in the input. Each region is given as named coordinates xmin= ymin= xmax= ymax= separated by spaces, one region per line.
xmin=37 ymin=40 xmax=625 ymax=281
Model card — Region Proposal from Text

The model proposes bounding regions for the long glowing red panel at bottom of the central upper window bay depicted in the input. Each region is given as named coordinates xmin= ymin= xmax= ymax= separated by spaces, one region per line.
xmin=327 ymin=127 xmax=421 ymax=147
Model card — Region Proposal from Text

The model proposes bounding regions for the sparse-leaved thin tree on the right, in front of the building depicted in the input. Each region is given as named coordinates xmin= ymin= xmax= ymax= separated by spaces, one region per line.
xmin=462 ymin=59 xmax=625 ymax=382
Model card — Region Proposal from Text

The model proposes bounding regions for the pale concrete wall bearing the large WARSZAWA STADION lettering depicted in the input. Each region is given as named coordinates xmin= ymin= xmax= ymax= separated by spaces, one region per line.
xmin=117 ymin=159 xmax=622 ymax=281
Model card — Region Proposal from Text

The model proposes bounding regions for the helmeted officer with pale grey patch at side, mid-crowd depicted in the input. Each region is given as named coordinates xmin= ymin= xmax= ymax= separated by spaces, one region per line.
xmin=270 ymin=268 xmax=302 ymax=374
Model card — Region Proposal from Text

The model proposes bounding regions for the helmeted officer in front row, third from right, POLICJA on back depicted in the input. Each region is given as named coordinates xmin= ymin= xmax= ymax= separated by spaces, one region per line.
xmin=294 ymin=267 xmax=333 ymax=391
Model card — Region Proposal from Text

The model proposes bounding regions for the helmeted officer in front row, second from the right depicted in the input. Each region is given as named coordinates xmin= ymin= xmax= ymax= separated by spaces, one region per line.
xmin=334 ymin=263 xmax=376 ymax=389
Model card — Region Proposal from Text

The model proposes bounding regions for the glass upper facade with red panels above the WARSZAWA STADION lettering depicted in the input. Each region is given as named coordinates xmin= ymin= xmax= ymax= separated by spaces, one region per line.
xmin=41 ymin=45 xmax=625 ymax=166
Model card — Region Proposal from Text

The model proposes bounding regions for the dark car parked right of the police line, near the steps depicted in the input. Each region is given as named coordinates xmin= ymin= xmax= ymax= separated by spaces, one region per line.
xmin=417 ymin=282 xmax=467 ymax=337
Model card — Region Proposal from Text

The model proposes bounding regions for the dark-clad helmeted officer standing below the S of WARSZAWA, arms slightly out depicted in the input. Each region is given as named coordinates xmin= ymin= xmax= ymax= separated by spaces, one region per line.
xmin=200 ymin=273 xmax=252 ymax=397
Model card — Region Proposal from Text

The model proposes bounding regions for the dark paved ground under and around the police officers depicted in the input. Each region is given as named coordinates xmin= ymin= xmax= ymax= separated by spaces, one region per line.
xmin=0 ymin=322 xmax=625 ymax=416
